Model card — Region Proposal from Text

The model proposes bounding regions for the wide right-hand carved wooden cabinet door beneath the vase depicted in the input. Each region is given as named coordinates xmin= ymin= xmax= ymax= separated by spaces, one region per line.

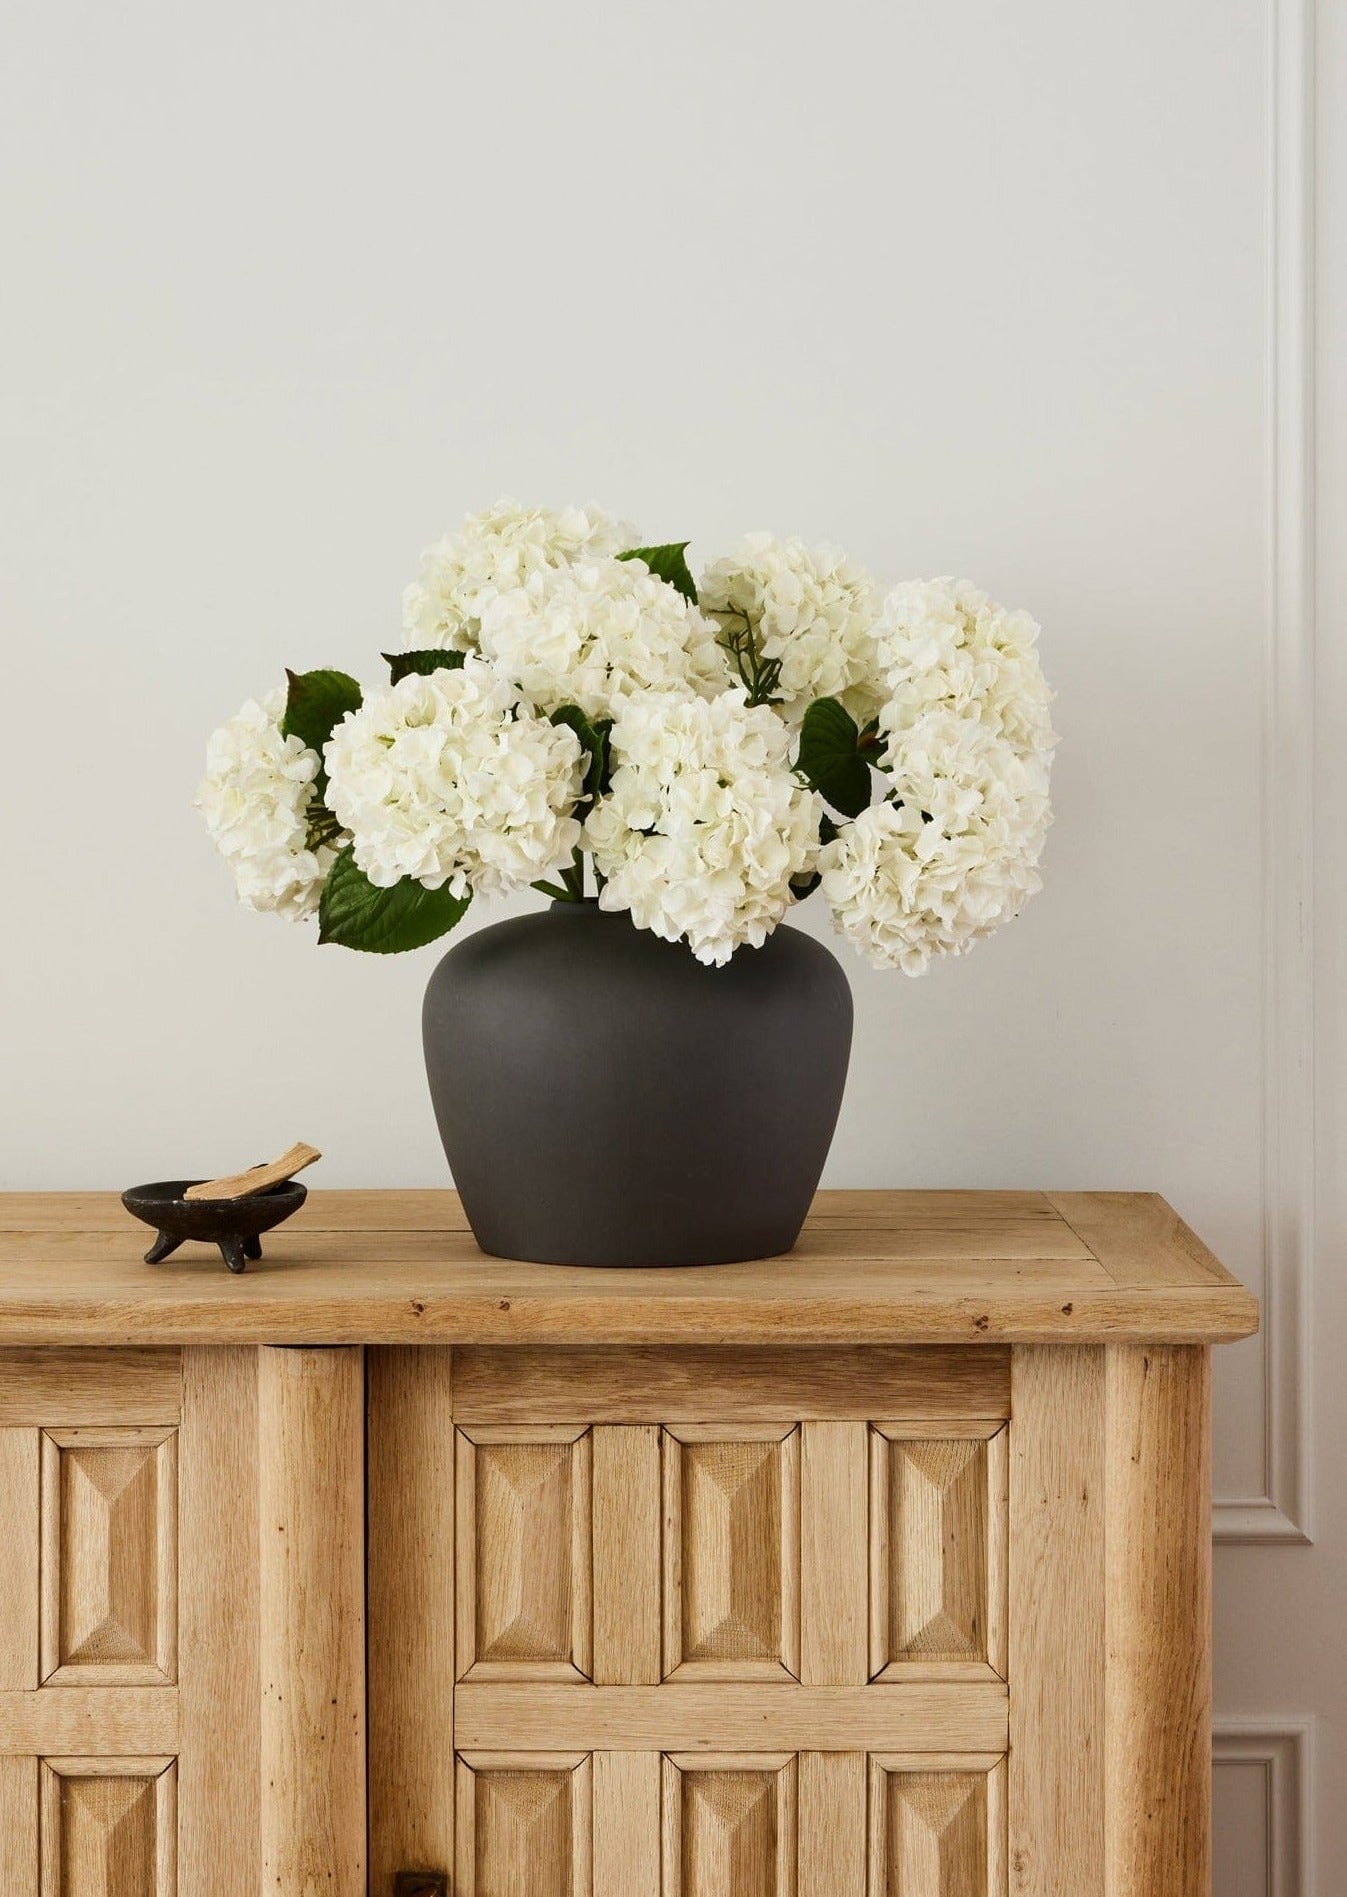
xmin=368 ymin=1349 xmax=1009 ymax=1897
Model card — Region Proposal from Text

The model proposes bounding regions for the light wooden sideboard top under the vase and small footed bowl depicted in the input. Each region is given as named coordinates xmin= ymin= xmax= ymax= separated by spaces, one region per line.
xmin=0 ymin=1191 xmax=1258 ymax=1345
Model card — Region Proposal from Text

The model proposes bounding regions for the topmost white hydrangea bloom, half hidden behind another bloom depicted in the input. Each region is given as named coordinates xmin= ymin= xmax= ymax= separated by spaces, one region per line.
xmin=402 ymin=497 xmax=641 ymax=651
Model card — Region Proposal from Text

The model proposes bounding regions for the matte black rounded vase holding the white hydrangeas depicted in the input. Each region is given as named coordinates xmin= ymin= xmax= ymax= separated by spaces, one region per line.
xmin=423 ymin=901 xmax=852 ymax=1265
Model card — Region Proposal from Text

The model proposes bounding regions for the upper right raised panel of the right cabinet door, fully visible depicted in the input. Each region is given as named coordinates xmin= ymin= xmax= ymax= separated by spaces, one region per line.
xmin=871 ymin=1423 xmax=1007 ymax=1679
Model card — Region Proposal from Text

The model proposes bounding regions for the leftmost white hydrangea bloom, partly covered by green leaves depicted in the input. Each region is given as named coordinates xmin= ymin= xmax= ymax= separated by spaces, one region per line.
xmin=195 ymin=689 xmax=334 ymax=922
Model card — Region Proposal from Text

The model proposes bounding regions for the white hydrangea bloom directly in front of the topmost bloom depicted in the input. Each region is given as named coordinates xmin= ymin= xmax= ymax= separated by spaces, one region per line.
xmin=480 ymin=560 xmax=729 ymax=717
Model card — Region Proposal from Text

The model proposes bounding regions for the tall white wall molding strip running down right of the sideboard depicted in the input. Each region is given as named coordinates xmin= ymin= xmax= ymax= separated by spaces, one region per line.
xmin=1212 ymin=0 xmax=1315 ymax=1542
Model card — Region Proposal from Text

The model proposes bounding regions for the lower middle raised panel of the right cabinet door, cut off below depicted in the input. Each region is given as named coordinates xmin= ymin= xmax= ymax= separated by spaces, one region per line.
xmin=662 ymin=1753 xmax=797 ymax=1897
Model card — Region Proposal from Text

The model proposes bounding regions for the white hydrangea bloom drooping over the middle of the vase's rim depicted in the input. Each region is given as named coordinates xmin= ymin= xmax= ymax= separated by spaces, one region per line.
xmin=584 ymin=689 xmax=821 ymax=964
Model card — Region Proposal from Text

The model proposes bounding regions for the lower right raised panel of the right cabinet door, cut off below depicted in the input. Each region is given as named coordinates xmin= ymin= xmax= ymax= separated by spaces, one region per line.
xmin=869 ymin=1759 xmax=1009 ymax=1897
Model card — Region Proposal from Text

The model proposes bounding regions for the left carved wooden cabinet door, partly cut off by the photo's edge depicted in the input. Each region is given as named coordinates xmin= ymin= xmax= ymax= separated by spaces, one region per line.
xmin=0 ymin=1351 xmax=260 ymax=1897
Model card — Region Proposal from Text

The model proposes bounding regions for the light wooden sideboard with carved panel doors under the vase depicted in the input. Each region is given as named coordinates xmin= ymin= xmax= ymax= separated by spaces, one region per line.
xmin=0 ymin=1191 xmax=1258 ymax=1897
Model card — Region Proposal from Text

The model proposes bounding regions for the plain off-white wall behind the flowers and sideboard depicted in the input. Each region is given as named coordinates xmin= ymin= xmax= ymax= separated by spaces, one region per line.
xmin=0 ymin=0 xmax=1347 ymax=1897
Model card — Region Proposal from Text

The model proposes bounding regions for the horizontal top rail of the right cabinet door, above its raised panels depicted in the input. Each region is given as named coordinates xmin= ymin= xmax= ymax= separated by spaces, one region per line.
xmin=453 ymin=1345 xmax=1009 ymax=1425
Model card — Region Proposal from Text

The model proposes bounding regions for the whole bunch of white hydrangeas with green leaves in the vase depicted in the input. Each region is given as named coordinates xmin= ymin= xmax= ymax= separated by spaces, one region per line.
xmin=197 ymin=501 xmax=1057 ymax=975
